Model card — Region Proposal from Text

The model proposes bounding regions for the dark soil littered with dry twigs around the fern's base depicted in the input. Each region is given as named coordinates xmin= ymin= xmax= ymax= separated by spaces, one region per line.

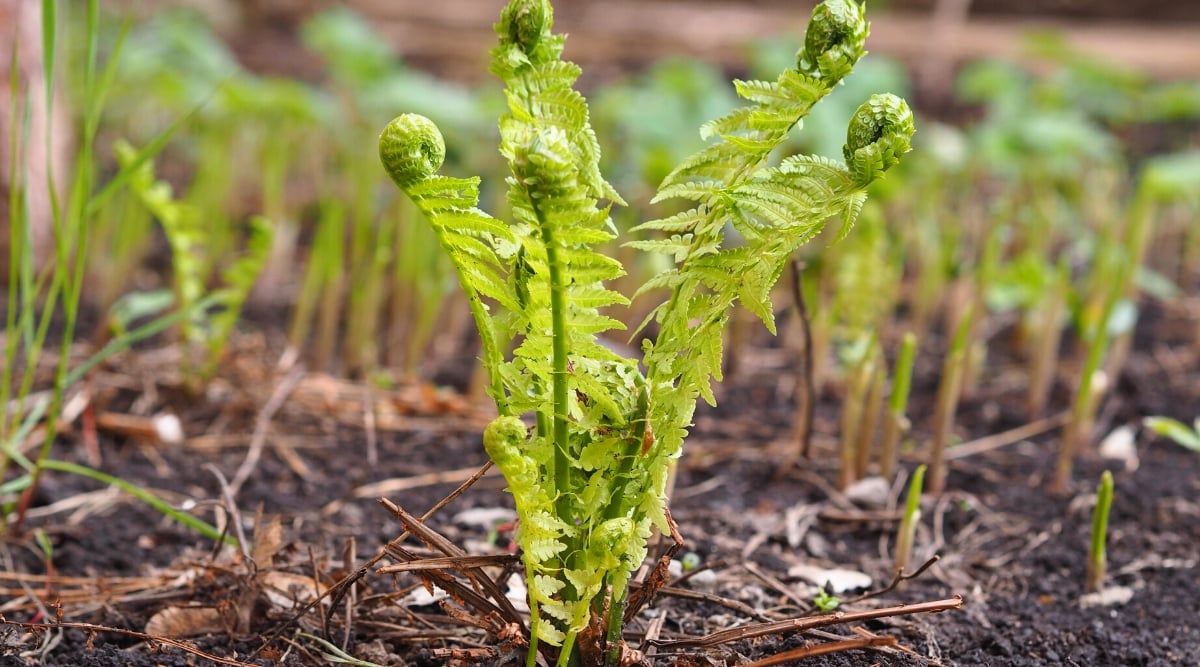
xmin=0 ymin=297 xmax=1200 ymax=667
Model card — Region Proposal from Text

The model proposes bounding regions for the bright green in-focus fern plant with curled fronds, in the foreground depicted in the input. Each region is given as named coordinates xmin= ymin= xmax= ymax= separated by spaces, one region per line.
xmin=379 ymin=0 xmax=913 ymax=666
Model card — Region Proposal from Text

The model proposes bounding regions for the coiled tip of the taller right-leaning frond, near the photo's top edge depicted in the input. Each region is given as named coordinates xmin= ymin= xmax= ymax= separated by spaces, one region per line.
xmin=796 ymin=0 xmax=870 ymax=85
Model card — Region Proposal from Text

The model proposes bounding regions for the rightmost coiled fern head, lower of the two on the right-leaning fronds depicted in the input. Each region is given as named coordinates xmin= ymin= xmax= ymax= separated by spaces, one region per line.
xmin=842 ymin=92 xmax=916 ymax=184
